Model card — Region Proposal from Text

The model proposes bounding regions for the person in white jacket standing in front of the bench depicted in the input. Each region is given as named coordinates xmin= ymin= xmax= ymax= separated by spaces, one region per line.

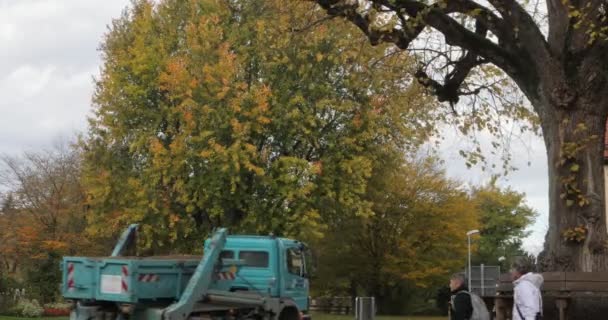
xmin=511 ymin=262 xmax=544 ymax=320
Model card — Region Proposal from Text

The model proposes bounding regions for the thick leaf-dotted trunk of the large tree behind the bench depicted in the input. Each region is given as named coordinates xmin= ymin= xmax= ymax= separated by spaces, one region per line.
xmin=539 ymin=104 xmax=608 ymax=272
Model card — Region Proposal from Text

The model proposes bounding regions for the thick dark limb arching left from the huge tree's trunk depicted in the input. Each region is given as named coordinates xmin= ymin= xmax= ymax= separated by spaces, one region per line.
xmin=309 ymin=0 xmax=576 ymax=110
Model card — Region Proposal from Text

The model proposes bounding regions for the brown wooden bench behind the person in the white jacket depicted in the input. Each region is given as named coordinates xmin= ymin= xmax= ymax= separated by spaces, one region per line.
xmin=494 ymin=272 xmax=608 ymax=320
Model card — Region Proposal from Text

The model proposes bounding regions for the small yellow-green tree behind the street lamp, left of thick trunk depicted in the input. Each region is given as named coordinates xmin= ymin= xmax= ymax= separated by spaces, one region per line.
xmin=471 ymin=179 xmax=538 ymax=271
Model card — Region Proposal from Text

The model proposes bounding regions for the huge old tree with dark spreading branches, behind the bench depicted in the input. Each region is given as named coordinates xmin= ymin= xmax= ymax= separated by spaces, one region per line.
xmin=314 ymin=0 xmax=608 ymax=271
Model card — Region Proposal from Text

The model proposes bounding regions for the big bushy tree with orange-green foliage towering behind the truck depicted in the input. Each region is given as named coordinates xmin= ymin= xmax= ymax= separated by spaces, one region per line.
xmin=83 ymin=0 xmax=435 ymax=251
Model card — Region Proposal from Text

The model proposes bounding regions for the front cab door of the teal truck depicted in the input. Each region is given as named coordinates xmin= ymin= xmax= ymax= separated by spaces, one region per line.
xmin=284 ymin=247 xmax=308 ymax=310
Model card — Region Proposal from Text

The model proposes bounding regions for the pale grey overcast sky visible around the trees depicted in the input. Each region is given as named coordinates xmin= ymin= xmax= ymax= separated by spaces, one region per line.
xmin=0 ymin=0 xmax=548 ymax=252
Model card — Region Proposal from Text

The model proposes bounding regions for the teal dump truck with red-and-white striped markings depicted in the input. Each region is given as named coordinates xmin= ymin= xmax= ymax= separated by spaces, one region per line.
xmin=61 ymin=225 xmax=310 ymax=320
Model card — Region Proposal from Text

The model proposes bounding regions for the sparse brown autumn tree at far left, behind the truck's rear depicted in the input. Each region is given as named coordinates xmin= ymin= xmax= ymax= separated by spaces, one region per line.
xmin=0 ymin=142 xmax=96 ymax=256
